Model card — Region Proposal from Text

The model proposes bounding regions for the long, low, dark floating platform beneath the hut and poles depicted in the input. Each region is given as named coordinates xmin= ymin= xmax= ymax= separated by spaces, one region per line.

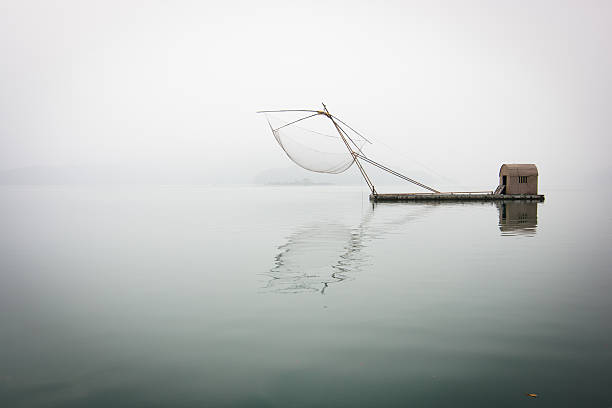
xmin=370 ymin=193 xmax=544 ymax=201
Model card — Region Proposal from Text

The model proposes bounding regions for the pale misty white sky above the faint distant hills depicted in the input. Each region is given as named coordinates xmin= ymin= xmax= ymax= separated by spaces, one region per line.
xmin=0 ymin=0 xmax=612 ymax=188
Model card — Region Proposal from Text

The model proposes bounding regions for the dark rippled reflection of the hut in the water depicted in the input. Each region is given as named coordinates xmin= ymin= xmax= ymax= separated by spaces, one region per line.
xmin=497 ymin=201 xmax=538 ymax=235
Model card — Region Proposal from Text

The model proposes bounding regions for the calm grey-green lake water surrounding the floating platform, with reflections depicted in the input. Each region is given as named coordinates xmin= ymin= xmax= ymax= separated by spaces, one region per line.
xmin=0 ymin=186 xmax=612 ymax=408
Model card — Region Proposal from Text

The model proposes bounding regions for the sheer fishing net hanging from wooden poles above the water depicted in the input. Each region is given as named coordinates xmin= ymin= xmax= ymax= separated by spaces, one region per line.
xmin=266 ymin=112 xmax=365 ymax=174
